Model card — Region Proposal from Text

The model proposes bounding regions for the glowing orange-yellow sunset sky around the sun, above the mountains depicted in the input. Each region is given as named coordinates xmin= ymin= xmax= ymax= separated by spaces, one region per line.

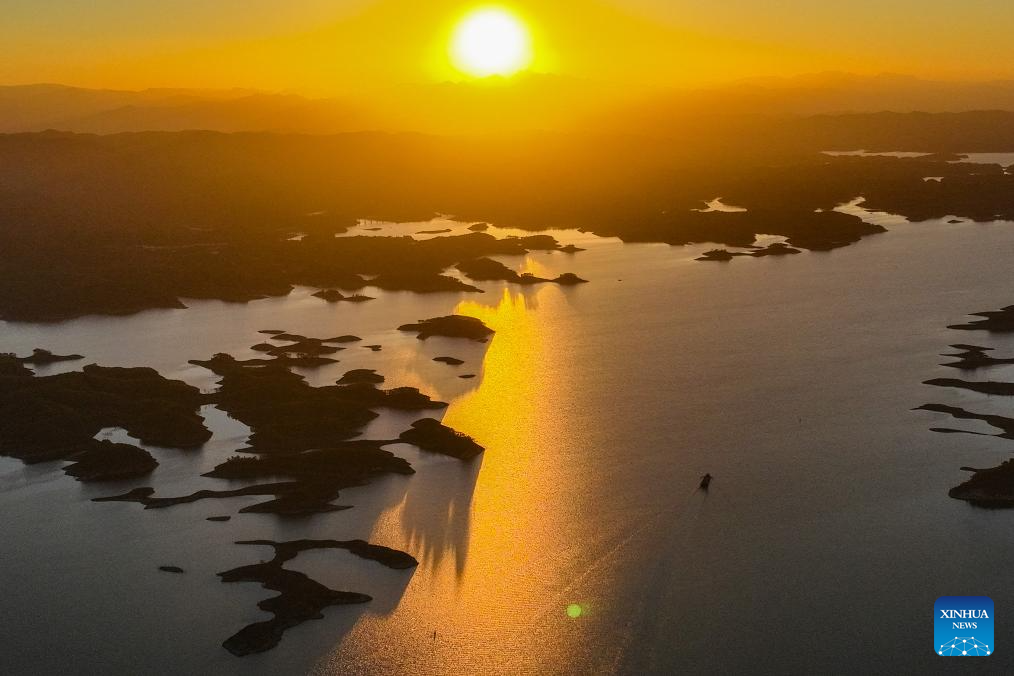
xmin=0 ymin=0 xmax=1014 ymax=94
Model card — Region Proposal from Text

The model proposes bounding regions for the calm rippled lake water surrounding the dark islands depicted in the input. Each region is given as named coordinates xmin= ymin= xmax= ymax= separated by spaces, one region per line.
xmin=0 ymin=206 xmax=1014 ymax=675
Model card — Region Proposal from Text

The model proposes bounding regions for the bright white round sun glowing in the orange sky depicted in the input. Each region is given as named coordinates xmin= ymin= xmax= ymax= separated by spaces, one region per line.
xmin=450 ymin=7 xmax=532 ymax=77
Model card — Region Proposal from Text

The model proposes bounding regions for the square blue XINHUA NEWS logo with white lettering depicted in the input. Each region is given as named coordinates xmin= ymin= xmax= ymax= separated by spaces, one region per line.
xmin=933 ymin=596 xmax=996 ymax=657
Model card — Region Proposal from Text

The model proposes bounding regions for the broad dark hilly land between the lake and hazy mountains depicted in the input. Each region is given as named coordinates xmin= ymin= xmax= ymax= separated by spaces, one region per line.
xmin=0 ymin=130 xmax=1014 ymax=321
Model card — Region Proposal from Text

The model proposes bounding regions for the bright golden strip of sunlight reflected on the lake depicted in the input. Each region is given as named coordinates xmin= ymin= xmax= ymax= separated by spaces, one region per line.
xmin=318 ymin=283 xmax=589 ymax=673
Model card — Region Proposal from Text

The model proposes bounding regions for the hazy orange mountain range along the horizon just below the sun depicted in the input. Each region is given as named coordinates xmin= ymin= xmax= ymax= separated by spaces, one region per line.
xmin=0 ymin=73 xmax=1014 ymax=135
